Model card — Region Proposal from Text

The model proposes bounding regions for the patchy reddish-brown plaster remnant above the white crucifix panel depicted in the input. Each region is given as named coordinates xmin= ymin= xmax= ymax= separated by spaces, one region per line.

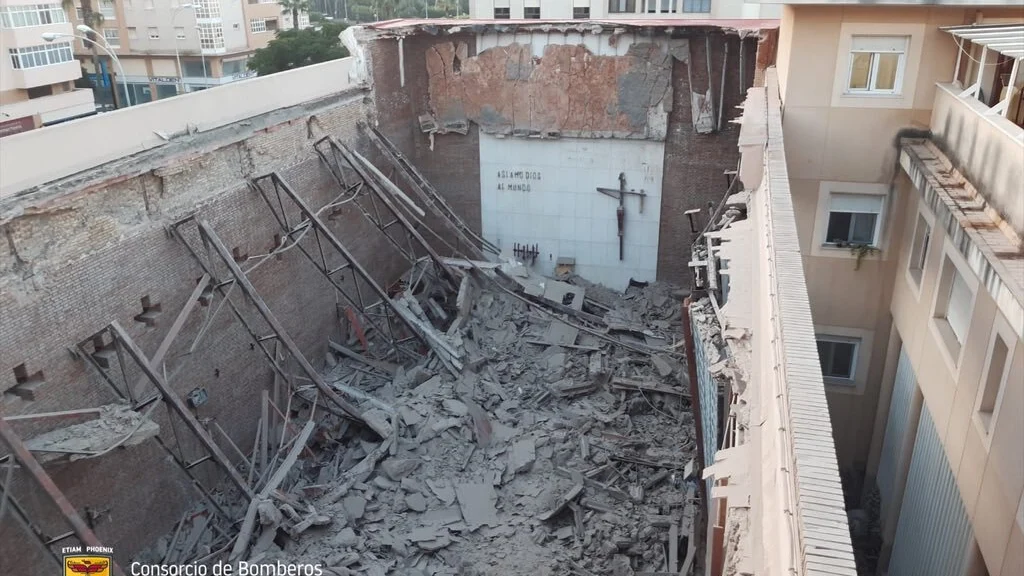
xmin=425 ymin=36 xmax=688 ymax=140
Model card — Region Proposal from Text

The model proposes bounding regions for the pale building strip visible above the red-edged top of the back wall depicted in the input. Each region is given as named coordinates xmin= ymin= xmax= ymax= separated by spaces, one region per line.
xmin=469 ymin=0 xmax=779 ymax=20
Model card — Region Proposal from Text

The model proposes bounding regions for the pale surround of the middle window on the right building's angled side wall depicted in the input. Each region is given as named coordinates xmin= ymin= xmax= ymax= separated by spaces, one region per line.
xmin=928 ymin=238 xmax=979 ymax=368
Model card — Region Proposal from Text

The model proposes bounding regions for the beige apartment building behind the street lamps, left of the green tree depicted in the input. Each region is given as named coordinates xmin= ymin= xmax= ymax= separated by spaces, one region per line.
xmin=69 ymin=0 xmax=309 ymax=105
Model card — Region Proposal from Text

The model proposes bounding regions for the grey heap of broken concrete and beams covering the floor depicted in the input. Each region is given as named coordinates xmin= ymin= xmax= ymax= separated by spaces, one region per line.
xmin=136 ymin=260 xmax=699 ymax=576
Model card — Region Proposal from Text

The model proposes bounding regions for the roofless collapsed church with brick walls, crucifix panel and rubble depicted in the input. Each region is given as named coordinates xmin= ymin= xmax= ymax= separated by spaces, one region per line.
xmin=0 ymin=15 xmax=827 ymax=575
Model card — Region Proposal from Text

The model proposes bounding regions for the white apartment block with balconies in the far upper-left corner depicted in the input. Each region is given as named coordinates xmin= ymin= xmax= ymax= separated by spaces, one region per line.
xmin=0 ymin=0 xmax=95 ymax=131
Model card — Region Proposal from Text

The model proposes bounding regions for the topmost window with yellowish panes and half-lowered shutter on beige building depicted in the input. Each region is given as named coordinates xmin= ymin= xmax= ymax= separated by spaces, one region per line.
xmin=847 ymin=36 xmax=909 ymax=94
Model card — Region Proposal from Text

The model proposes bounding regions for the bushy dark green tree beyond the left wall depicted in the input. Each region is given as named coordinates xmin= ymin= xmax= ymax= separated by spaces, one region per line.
xmin=248 ymin=23 xmax=348 ymax=76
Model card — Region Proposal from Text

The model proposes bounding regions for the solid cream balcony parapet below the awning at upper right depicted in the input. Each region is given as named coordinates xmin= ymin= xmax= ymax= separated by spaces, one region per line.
xmin=931 ymin=84 xmax=1024 ymax=235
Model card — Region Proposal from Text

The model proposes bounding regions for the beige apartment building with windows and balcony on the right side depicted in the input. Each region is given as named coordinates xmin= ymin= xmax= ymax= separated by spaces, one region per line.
xmin=777 ymin=2 xmax=1024 ymax=576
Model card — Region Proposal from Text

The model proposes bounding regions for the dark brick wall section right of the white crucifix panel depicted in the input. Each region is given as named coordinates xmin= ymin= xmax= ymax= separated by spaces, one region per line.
xmin=657 ymin=34 xmax=757 ymax=284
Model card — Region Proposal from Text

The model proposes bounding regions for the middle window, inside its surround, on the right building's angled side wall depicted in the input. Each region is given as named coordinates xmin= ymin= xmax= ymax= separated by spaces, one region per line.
xmin=932 ymin=249 xmax=978 ymax=360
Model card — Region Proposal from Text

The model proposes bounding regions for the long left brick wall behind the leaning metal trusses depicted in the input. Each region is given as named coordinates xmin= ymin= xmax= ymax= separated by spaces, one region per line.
xmin=0 ymin=93 xmax=411 ymax=574
